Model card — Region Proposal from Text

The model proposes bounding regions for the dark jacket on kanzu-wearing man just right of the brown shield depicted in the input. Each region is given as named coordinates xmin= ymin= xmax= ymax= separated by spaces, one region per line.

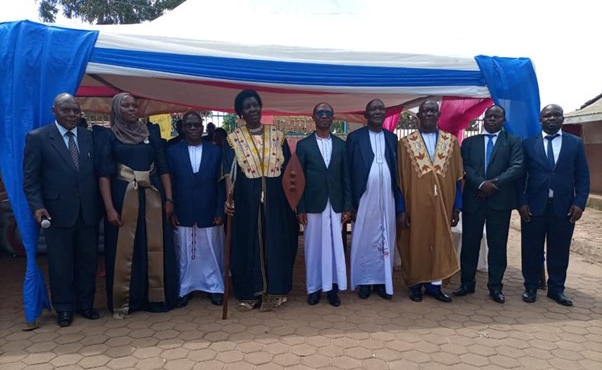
xmin=296 ymin=132 xmax=352 ymax=213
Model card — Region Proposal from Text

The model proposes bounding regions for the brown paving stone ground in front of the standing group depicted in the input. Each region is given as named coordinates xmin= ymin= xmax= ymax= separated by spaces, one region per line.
xmin=0 ymin=210 xmax=602 ymax=370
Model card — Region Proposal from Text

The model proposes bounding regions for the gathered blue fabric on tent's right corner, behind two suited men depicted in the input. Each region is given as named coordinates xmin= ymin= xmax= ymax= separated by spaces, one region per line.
xmin=475 ymin=55 xmax=541 ymax=139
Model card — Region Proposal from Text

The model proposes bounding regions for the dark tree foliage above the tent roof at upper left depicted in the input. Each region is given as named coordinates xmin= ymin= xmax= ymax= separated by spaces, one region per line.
xmin=36 ymin=0 xmax=185 ymax=24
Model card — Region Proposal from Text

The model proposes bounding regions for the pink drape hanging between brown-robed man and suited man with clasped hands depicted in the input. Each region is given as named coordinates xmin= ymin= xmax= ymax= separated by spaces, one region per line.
xmin=439 ymin=96 xmax=493 ymax=144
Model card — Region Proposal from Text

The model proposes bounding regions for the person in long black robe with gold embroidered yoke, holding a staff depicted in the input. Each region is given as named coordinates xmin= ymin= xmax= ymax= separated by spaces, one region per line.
xmin=223 ymin=90 xmax=298 ymax=311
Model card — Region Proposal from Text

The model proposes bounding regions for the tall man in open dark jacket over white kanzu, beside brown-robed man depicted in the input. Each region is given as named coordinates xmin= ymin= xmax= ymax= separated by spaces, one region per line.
xmin=347 ymin=99 xmax=405 ymax=299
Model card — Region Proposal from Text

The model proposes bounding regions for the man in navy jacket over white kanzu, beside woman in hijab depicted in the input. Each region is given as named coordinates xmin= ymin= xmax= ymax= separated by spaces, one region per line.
xmin=167 ymin=111 xmax=225 ymax=307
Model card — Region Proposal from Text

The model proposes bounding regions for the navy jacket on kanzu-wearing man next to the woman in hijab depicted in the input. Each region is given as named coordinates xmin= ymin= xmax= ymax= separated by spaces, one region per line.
xmin=167 ymin=141 xmax=226 ymax=227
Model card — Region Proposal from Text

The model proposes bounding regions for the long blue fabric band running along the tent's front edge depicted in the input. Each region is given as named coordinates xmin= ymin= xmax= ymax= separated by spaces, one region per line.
xmin=90 ymin=47 xmax=485 ymax=87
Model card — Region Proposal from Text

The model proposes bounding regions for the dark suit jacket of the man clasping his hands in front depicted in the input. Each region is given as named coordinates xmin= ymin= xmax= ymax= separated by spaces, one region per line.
xmin=461 ymin=130 xmax=523 ymax=212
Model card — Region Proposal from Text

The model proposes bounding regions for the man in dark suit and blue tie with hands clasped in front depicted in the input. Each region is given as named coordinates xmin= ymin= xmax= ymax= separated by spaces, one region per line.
xmin=454 ymin=105 xmax=523 ymax=303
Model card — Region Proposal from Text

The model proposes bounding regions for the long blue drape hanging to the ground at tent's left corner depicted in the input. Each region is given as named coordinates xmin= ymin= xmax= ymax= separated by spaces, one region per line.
xmin=0 ymin=21 xmax=98 ymax=323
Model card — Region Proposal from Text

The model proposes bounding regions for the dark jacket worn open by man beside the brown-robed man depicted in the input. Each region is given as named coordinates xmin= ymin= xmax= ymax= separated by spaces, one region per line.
xmin=347 ymin=126 xmax=405 ymax=213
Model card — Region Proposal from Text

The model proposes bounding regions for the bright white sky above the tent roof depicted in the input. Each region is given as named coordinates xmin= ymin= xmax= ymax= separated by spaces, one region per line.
xmin=0 ymin=0 xmax=602 ymax=112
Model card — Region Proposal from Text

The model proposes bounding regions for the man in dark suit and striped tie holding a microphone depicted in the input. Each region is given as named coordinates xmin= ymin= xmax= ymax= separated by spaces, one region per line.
xmin=23 ymin=93 xmax=99 ymax=327
